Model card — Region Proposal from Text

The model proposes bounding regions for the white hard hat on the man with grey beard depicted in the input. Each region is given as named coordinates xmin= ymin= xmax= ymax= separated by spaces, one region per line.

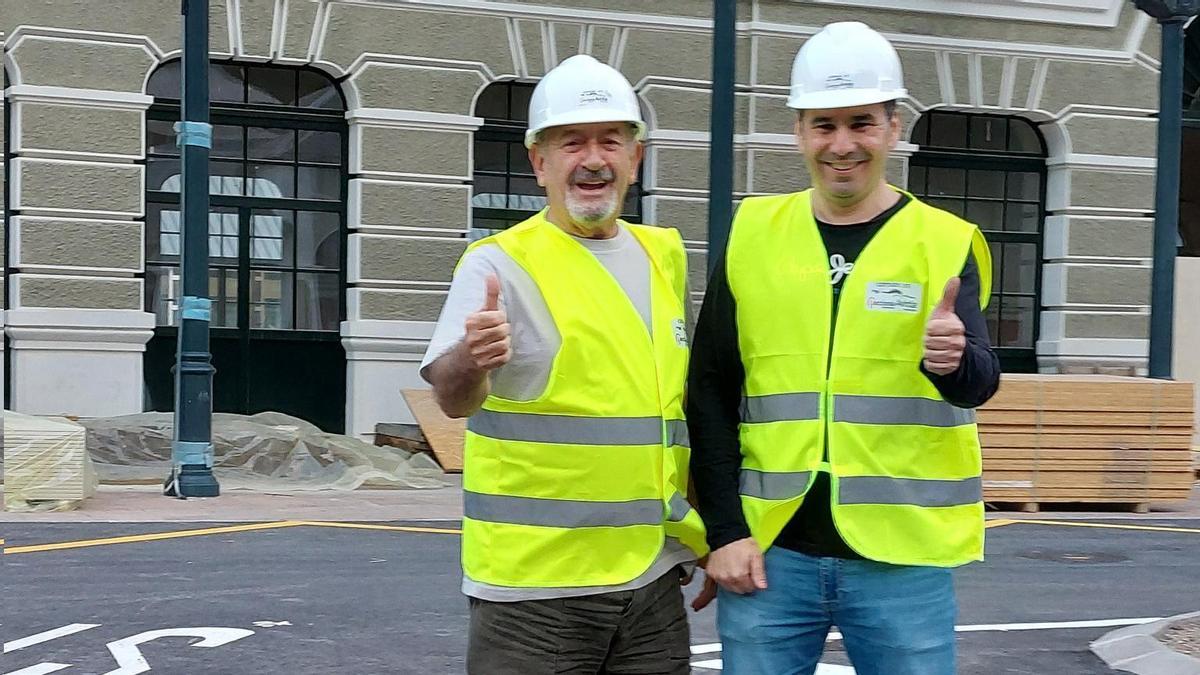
xmin=526 ymin=54 xmax=646 ymax=148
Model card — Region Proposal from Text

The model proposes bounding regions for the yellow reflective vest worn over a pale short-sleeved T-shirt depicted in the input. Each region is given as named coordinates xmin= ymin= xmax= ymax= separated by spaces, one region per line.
xmin=462 ymin=214 xmax=707 ymax=587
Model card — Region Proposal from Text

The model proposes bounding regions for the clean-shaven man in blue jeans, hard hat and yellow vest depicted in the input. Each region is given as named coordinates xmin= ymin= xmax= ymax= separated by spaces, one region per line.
xmin=689 ymin=23 xmax=1000 ymax=675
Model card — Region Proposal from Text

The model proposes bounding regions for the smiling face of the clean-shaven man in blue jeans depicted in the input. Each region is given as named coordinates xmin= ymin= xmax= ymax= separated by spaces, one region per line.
xmin=796 ymin=103 xmax=900 ymax=208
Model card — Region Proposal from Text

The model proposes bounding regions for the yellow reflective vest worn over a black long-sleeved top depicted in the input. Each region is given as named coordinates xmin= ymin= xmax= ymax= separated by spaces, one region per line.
xmin=726 ymin=191 xmax=991 ymax=567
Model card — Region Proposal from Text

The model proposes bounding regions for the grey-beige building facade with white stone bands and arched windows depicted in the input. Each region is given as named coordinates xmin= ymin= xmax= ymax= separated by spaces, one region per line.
xmin=0 ymin=0 xmax=1200 ymax=434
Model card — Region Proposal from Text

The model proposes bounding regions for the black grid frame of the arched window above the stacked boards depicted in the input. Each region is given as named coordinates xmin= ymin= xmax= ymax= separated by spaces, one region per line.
xmin=907 ymin=110 xmax=1049 ymax=372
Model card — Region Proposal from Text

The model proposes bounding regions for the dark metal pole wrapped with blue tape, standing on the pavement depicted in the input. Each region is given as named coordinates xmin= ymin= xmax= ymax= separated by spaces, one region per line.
xmin=164 ymin=0 xmax=221 ymax=497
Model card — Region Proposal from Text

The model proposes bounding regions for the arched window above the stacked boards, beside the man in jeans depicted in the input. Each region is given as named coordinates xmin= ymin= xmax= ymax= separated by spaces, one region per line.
xmin=908 ymin=110 xmax=1046 ymax=372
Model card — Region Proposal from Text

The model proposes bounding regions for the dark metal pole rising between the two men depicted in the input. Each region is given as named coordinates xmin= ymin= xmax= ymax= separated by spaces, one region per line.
xmin=708 ymin=0 xmax=738 ymax=274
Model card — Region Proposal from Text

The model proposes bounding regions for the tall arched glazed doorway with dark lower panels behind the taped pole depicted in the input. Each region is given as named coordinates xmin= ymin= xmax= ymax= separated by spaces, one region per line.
xmin=145 ymin=61 xmax=348 ymax=431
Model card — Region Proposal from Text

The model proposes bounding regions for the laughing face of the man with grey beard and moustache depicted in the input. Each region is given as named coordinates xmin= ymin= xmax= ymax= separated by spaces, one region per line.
xmin=529 ymin=123 xmax=642 ymax=237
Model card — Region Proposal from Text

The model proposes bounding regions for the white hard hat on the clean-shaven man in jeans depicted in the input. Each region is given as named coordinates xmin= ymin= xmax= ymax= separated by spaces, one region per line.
xmin=787 ymin=22 xmax=908 ymax=110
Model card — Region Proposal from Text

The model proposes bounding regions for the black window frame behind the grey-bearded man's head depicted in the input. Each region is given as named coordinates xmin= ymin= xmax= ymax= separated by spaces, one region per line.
xmin=470 ymin=79 xmax=646 ymax=233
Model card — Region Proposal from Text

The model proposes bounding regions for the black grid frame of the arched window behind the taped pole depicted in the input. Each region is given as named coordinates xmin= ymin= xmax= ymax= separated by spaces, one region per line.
xmin=142 ymin=60 xmax=353 ymax=341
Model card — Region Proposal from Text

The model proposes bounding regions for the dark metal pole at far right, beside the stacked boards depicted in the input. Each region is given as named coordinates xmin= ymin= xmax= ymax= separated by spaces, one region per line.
xmin=1150 ymin=17 xmax=1186 ymax=380
